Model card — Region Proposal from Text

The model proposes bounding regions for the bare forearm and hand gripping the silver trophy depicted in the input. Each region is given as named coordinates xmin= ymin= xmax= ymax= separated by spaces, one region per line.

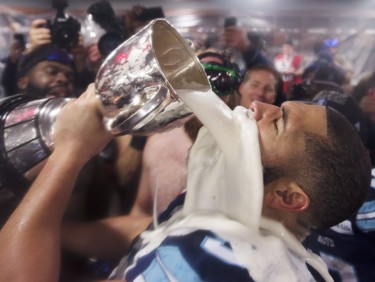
xmin=0 ymin=85 xmax=111 ymax=281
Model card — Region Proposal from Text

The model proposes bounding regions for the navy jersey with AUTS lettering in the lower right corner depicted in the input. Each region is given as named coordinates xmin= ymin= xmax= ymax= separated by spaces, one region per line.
xmin=304 ymin=169 xmax=375 ymax=282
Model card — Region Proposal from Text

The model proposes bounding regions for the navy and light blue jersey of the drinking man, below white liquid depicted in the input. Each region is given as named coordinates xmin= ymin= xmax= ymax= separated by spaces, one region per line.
xmin=110 ymin=194 xmax=254 ymax=282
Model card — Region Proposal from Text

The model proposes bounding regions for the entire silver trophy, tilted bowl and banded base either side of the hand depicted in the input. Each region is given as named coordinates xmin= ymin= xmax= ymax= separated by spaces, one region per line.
xmin=0 ymin=19 xmax=210 ymax=195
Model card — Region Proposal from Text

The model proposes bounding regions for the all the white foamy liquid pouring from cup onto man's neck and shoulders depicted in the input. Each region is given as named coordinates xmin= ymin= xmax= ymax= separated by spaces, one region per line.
xmin=129 ymin=88 xmax=333 ymax=281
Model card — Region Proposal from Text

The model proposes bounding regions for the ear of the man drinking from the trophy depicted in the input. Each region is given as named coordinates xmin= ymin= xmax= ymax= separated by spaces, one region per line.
xmin=264 ymin=178 xmax=310 ymax=212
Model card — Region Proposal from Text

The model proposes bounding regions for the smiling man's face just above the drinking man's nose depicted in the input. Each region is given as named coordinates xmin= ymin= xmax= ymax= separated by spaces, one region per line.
xmin=239 ymin=70 xmax=277 ymax=108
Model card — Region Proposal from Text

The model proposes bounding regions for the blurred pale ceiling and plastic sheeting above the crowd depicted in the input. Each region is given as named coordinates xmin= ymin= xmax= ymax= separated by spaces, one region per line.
xmin=0 ymin=0 xmax=375 ymax=81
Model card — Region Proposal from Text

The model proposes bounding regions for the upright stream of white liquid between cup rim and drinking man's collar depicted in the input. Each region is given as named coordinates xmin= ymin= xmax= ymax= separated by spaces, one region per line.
xmin=178 ymin=91 xmax=263 ymax=230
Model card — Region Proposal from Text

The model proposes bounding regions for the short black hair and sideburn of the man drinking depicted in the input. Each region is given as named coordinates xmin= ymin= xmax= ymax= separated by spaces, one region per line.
xmin=264 ymin=107 xmax=371 ymax=229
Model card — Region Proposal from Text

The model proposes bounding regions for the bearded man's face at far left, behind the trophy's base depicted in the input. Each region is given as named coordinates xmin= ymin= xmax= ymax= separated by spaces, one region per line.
xmin=22 ymin=61 xmax=73 ymax=98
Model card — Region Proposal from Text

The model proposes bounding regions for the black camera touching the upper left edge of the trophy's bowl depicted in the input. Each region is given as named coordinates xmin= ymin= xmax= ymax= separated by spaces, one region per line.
xmin=87 ymin=0 xmax=129 ymax=57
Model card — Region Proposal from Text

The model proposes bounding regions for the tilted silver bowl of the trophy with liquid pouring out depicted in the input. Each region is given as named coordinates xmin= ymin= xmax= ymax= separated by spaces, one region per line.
xmin=95 ymin=19 xmax=210 ymax=135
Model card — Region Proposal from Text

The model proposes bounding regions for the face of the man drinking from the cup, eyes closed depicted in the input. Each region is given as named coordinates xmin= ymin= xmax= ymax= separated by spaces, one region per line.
xmin=250 ymin=102 xmax=327 ymax=167
